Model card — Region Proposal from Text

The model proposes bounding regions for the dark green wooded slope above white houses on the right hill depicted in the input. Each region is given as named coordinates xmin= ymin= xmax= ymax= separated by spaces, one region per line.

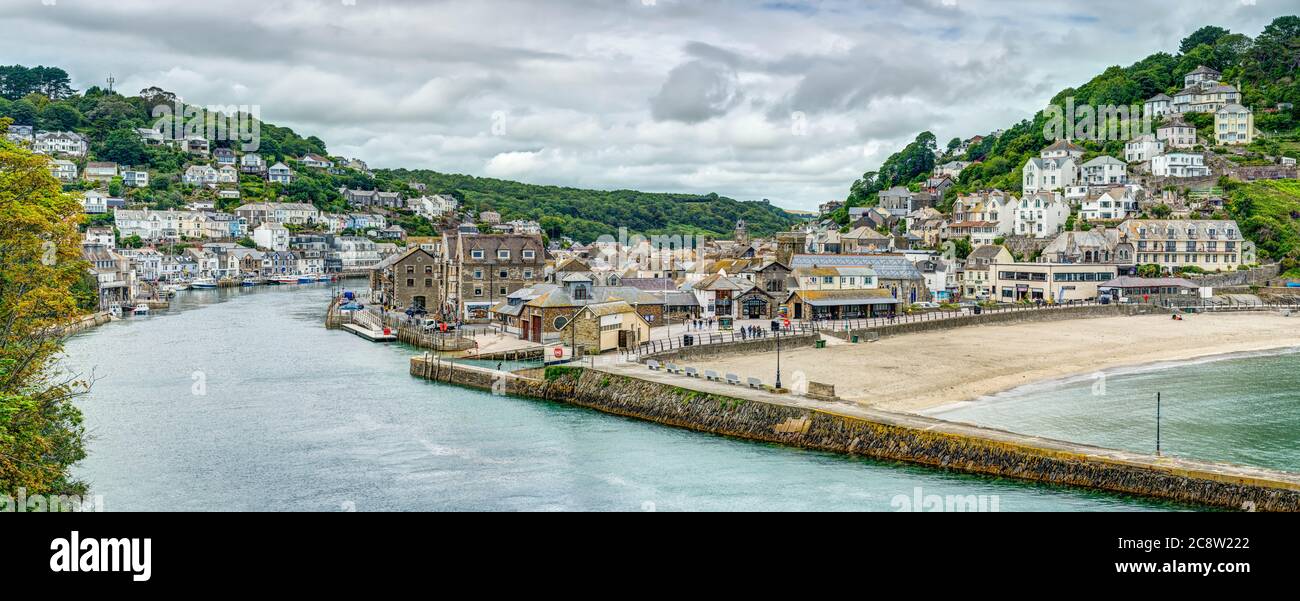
xmin=835 ymin=16 xmax=1300 ymax=222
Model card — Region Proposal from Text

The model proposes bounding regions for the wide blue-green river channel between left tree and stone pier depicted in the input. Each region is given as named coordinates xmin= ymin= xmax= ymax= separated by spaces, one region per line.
xmin=65 ymin=285 xmax=1174 ymax=511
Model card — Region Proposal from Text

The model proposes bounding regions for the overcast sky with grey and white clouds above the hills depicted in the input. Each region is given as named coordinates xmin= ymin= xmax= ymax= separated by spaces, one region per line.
xmin=0 ymin=0 xmax=1300 ymax=211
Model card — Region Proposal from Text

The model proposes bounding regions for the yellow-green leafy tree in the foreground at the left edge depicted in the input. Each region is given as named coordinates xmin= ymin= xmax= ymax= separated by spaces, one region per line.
xmin=0 ymin=120 xmax=86 ymax=494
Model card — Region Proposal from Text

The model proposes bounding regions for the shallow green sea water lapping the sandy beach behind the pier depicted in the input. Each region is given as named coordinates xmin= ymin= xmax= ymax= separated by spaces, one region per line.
xmin=932 ymin=350 xmax=1300 ymax=471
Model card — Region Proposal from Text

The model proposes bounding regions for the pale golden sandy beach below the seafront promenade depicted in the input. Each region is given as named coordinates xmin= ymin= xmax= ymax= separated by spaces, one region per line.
xmin=692 ymin=314 xmax=1300 ymax=412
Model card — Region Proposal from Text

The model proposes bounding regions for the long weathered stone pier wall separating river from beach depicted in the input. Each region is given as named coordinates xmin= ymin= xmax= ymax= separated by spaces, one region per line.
xmin=410 ymin=356 xmax=1300 ymax=511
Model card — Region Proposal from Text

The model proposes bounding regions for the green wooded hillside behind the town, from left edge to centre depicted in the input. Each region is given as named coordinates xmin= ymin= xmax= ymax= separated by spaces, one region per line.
xmin=0 ymin=65 xmax=800 ymax=242
